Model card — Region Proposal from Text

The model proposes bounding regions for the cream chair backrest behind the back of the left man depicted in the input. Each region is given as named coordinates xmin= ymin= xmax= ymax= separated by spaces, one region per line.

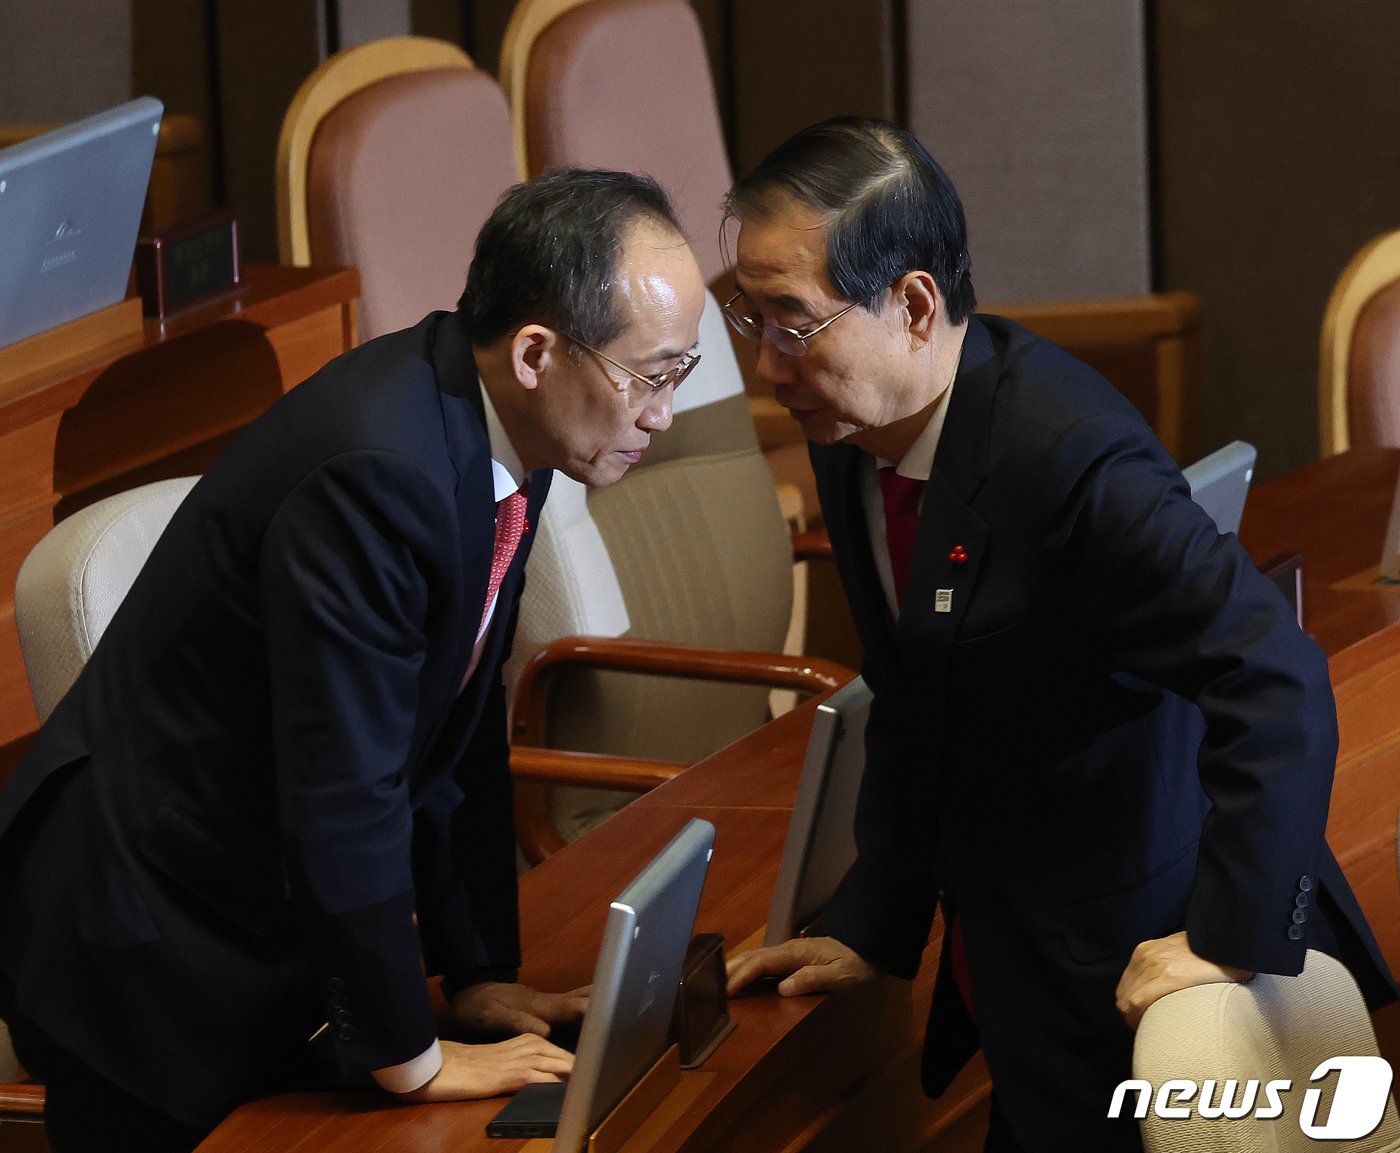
xmin=14 ymin=477 xmax=199 ymax=721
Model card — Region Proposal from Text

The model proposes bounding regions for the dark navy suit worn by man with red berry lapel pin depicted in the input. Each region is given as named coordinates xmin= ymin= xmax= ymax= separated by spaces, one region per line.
xmin=812 ymin=316 xmax=1390 ymax=1150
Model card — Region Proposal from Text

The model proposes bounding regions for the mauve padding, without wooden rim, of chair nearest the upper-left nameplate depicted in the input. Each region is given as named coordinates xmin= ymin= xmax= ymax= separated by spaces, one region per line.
xmin=307 ymin=69 xmax=515 ymax=339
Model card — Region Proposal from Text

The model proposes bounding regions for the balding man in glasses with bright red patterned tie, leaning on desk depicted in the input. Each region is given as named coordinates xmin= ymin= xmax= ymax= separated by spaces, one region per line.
xmin=0 ymin=172 xmax=704 ymax=1153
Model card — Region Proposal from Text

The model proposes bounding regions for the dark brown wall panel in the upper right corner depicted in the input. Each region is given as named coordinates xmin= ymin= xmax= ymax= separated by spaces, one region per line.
xmin=1155 ymin=0 xmax=1400 ymax=479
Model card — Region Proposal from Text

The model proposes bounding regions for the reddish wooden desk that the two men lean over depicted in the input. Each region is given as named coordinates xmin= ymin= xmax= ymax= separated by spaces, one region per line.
xmin=200 ymin=705 xmax=986 ymax=1153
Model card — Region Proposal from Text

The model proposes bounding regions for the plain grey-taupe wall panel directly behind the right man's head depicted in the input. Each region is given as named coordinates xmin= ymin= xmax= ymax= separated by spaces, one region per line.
xmin=909 ymin=0 xmax=1151 ymax=302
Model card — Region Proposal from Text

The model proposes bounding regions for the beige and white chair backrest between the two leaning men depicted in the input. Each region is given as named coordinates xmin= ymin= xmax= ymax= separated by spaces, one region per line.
xmin=508 ymin=288 xmax=792 ymax=831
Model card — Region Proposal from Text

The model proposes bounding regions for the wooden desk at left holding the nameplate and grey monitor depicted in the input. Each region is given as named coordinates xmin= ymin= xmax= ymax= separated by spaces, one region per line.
xmin=0 ymin=266 xmax=360 ymax=750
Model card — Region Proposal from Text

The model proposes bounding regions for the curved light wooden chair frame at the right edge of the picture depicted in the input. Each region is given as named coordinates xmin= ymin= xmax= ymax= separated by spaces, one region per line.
xmin=1317 ymin=231 xmax=1400 ymax=456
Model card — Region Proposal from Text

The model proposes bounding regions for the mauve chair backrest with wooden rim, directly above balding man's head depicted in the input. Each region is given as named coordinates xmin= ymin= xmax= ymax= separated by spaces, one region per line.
xmin=501 ymin=0 xmax=732 ymax=283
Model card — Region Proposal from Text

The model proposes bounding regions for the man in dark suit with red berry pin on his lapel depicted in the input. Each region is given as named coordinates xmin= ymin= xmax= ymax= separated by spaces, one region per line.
xmin=727 ymin=120 xmax=1393 ymax=1153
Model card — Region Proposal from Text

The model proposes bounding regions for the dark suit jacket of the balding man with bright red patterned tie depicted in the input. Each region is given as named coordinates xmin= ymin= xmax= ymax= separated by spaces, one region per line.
xmin=0 ymin=313 xmax=550 ymax=1125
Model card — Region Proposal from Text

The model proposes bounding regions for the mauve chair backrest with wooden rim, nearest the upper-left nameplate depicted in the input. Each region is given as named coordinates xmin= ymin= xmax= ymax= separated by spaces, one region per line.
xmin=277 ymin=36 xmax=515 ymax=339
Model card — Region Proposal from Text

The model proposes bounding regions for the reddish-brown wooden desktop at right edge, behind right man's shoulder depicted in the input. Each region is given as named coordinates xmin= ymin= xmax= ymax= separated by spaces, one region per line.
xmin=1239 ymin=448 xmax=1400 ymax=656
